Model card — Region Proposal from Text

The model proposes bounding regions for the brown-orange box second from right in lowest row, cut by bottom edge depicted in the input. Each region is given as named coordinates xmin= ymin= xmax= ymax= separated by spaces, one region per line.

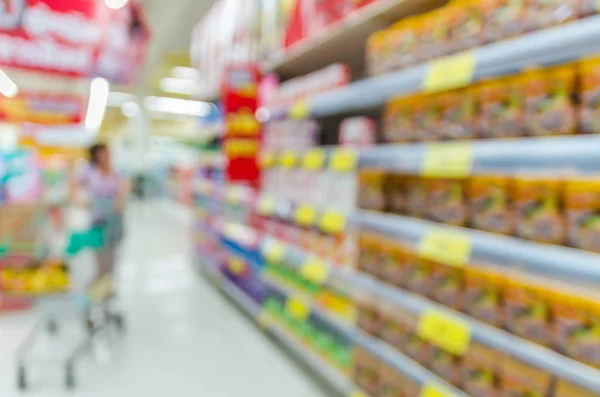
xmin=496 ymin=352 xmax=552 ymax=397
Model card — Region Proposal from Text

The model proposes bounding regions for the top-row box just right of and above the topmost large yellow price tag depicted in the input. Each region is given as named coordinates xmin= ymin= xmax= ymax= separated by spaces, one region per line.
xmin=481 ymin=0 xmax=527 ymax=43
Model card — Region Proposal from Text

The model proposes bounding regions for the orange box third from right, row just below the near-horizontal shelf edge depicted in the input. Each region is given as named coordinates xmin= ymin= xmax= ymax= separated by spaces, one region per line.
xmin=467 ymin=175 xmax=515 ymax=234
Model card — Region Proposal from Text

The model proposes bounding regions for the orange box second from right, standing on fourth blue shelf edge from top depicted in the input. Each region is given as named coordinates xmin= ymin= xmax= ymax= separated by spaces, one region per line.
xmin=504 ymin=274 xmax=552 ymax=346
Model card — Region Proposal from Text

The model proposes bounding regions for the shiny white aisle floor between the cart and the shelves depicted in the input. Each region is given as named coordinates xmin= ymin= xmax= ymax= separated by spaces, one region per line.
xmin=0 ymin=202 xmax=326 ymax=397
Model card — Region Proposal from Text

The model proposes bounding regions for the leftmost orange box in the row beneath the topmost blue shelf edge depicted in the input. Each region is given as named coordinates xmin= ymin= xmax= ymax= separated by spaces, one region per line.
xmin=383 ymin=97 xmax=414 ymax=143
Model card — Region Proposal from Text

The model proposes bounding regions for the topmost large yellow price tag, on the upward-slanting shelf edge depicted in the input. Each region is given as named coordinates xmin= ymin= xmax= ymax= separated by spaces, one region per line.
xmin=423 ymin=51 xmax=477 ymax=92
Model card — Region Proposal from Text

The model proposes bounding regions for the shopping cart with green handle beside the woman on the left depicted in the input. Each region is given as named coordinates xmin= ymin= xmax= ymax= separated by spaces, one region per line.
xmin=3 ymin=201 xmax=125 ymax=390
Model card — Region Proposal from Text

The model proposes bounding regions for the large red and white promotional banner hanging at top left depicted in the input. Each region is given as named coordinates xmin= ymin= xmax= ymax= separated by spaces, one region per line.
xmin=0 ymin=0 xmax=148 ymax=83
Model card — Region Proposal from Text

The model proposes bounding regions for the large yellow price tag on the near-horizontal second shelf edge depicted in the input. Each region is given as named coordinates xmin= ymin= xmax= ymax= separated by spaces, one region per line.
xmin=422 ymin=142 xmax=474 ymax=178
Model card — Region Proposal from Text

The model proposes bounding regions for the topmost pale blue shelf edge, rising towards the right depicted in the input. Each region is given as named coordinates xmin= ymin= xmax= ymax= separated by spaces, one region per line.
xmin=269 ymin=15 xmax=600 ymax=118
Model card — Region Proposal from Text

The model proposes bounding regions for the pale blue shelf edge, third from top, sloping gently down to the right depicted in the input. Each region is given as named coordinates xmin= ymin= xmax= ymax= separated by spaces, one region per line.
xmin=350 ymin=211 xmax=600 ymax=284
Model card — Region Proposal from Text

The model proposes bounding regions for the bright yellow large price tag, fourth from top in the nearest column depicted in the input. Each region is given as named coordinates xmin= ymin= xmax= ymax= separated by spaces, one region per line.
xmin=417 ymin=309 xmax=471 ymax=357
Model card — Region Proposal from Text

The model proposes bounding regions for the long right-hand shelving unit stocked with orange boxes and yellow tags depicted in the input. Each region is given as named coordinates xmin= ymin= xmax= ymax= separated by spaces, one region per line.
xmin=191 ymin=0 xmax=600 ymax=397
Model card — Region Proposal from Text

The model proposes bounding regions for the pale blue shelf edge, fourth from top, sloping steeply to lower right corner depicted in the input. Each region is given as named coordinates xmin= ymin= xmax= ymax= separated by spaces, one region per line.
xmin=345 ymin=274 xmax=600 ymax=393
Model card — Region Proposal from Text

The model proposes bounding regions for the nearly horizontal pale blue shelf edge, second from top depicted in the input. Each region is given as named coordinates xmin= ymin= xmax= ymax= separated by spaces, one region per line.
xmin=359 ymin=135 xmax=600 ymax=175
